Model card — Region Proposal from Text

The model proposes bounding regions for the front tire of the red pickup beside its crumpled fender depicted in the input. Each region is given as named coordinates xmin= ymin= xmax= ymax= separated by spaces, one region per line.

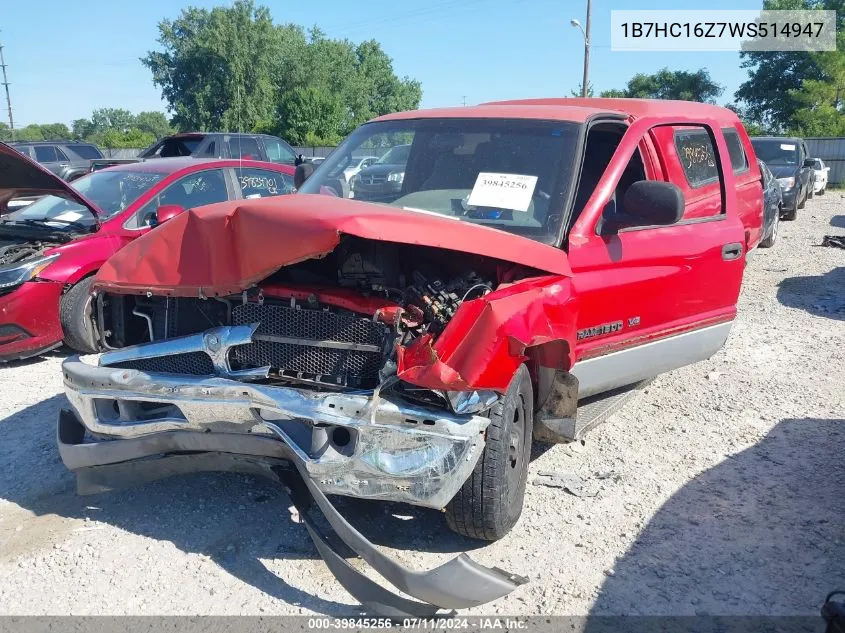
xmin=446 ymin=365 xmax=534 ymax=541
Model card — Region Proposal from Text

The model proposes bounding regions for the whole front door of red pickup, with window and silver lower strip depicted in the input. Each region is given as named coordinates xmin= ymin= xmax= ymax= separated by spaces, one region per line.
xmin=568 ymin=117 xmax=745 ymax=397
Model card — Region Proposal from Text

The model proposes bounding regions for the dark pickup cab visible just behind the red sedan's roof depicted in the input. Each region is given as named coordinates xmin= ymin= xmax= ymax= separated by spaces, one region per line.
xmin=138 ymin=132 xmax=302 ymax=165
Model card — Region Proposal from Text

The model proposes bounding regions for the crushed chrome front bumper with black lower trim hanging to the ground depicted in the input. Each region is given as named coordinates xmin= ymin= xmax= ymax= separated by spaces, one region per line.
xmin=57 ymin=357 xmax=527 ymax=617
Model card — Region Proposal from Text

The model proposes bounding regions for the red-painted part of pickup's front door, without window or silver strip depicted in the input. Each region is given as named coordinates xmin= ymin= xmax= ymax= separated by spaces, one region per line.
xmin=569 ymin=119 xmax=745 ymax=360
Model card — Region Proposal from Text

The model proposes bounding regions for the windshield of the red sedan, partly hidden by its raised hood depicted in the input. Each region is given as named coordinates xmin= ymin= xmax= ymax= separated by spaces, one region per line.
xmin=4 ymin=170 xmax=164 ymax=228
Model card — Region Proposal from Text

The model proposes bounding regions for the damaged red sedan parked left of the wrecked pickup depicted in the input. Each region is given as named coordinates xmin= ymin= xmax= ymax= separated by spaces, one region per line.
xmin=0 ymin=144 xmax=294 ymax=361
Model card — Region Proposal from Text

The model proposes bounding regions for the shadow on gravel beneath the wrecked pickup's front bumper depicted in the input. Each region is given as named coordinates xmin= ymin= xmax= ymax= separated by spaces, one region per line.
xmin=0 ymin=396 xmax=483 ymax=615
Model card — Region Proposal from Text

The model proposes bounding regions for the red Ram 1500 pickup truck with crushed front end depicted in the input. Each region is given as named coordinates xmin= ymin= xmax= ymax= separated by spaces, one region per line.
xmin=58 ymin=99 xmax=762 ymax=615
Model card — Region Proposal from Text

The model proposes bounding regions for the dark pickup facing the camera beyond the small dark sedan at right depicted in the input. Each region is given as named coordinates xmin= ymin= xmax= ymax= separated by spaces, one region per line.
xmin=751 ymin=136 xmax=813 ymax=220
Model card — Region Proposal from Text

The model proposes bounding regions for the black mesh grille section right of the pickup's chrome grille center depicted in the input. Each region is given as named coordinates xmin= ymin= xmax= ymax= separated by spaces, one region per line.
xmin=230 ymin=303 xmax=390 ymax=387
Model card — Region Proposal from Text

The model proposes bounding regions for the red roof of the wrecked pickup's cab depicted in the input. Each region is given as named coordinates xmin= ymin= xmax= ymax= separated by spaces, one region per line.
xmin=376 ymin=97 xmax=739 ymax=123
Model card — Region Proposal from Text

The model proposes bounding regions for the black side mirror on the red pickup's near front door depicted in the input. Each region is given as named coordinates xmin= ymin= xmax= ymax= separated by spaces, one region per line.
xmin=601 ymin=180 xmax=685 ymax=233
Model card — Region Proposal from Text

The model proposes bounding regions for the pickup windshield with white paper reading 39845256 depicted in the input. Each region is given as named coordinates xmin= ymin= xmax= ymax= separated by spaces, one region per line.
xmin=300 ymin=119 xmax=579 ymax=244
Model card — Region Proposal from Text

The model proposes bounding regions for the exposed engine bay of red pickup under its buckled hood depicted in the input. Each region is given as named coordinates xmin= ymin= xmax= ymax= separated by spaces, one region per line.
xmin=96 ymin=237 xmax=513 ymax=390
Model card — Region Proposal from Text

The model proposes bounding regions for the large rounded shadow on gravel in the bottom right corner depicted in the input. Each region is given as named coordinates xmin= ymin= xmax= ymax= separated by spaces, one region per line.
xmin=591 ymin=419 xmax=845 ymax=616
